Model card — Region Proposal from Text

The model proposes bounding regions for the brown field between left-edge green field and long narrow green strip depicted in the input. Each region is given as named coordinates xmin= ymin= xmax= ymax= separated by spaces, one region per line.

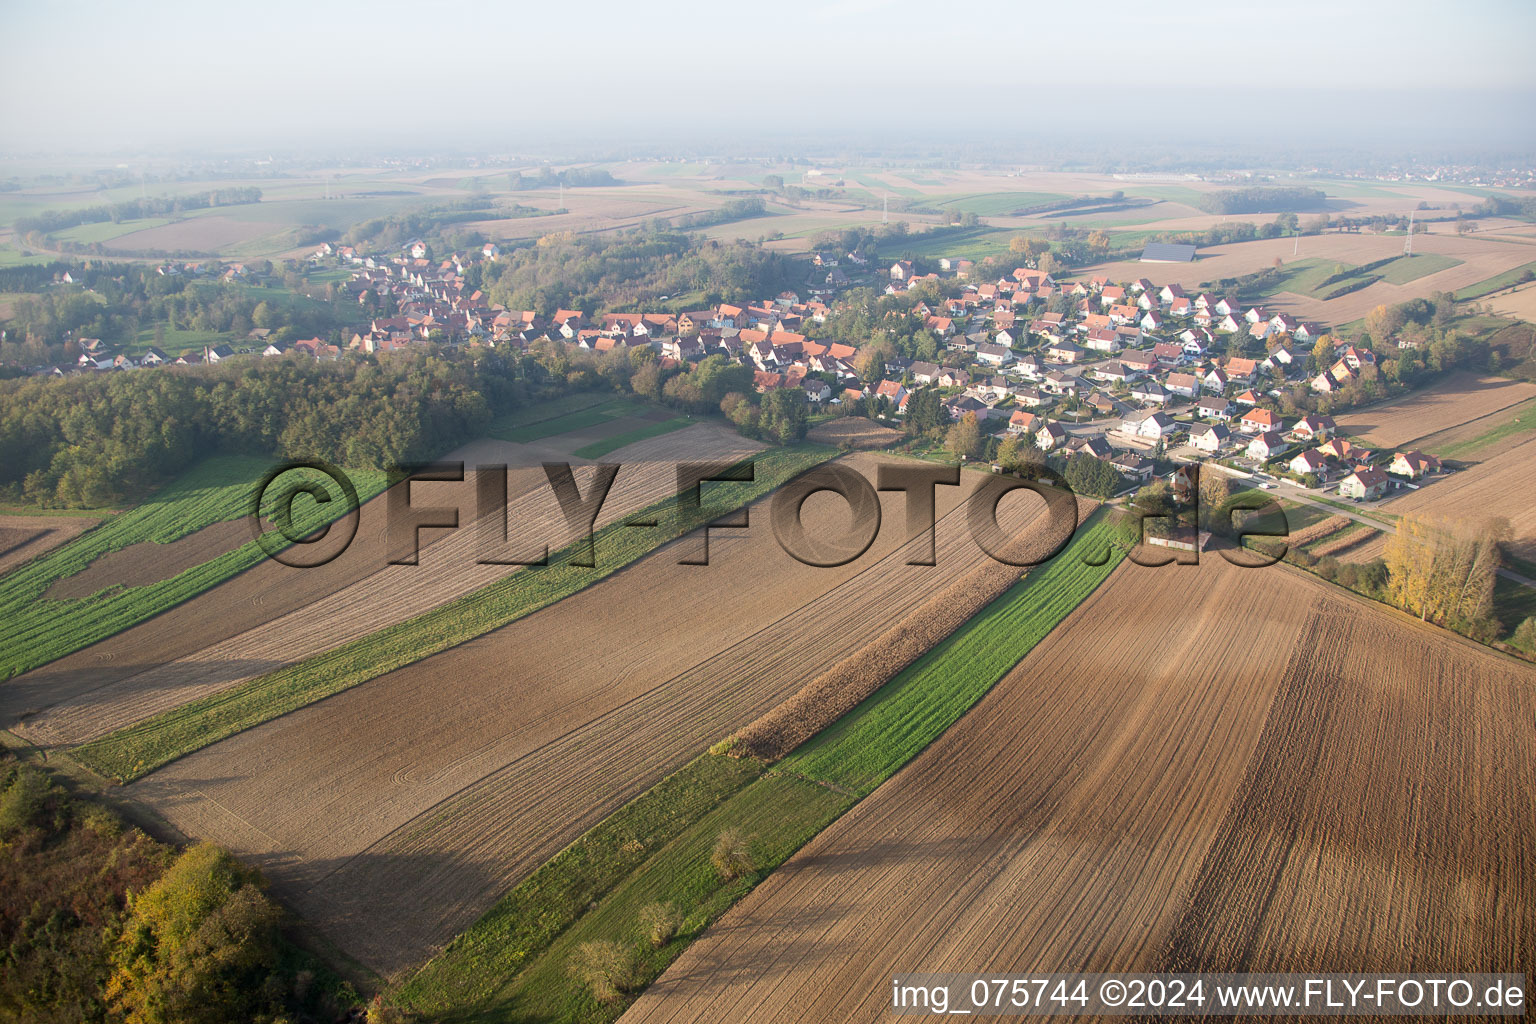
xmin=0 ymin=424 xmax=762 ymax=746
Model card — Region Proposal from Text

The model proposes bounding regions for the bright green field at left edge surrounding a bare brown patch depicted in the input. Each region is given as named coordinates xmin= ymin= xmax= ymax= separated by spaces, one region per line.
xmin=0 ymin=456 xmax=386 ymax=679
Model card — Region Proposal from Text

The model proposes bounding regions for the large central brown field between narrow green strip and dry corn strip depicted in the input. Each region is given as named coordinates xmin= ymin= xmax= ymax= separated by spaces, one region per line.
xmin=127 ymin=454 xmax=1069 ymax=972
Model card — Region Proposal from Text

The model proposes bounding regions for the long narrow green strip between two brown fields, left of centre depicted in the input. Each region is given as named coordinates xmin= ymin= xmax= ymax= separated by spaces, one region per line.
xmin=71 ymin=444 xmax=837 ymax=781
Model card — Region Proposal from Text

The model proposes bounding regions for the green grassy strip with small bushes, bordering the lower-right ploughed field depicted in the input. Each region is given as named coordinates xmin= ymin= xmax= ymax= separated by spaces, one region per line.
xmin=395 ymin=513 xmax=1142 ymax=1021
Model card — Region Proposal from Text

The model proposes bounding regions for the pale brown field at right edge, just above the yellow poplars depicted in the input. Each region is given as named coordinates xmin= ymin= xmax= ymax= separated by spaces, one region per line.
xmin=1347 ymin=439 xmax=1536 ymax=562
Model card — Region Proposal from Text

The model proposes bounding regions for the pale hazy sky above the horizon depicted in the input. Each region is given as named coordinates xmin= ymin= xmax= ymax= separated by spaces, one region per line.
xmin=0 ymin=0 xmax=1536 ymax=154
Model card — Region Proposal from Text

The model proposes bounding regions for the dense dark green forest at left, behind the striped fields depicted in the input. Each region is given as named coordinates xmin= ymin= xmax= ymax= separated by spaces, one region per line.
xmin=0 ymin=350 xmax=522 ymax=507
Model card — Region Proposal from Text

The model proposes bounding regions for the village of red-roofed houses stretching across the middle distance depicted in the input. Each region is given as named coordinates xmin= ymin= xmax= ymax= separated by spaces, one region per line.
xmin=46 ymin=234 xmax=1445 ymax=515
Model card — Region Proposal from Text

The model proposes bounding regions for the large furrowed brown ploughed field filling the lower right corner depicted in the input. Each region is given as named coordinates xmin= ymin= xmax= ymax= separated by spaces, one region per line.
xmin=624 ymin=559 xmax=1536 ymax=1022
